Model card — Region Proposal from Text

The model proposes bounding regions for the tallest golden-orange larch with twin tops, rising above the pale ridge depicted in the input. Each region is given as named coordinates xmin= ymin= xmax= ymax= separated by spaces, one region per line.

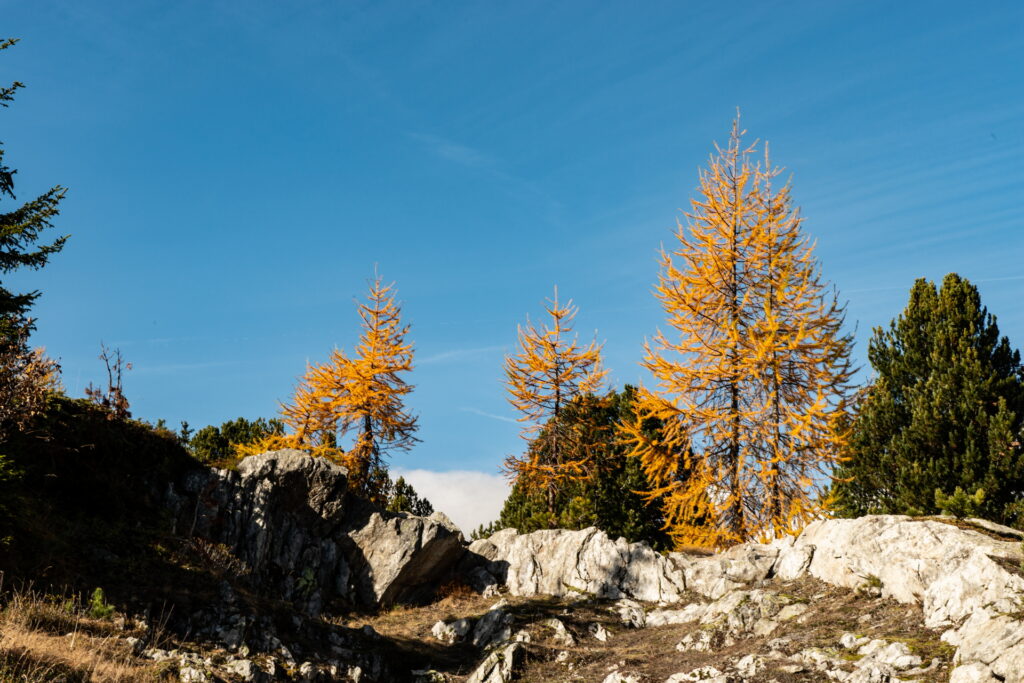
xmin=624 ymin=117 xmax=852 ymax=547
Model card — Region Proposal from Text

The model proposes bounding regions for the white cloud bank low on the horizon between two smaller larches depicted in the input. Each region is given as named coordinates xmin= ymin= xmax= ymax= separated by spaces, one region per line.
xmin=391 ymin=468 xmax=511 ymax=539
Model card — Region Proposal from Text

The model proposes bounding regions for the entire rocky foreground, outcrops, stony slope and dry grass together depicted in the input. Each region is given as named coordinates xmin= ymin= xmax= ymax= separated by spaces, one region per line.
xmin=0 ymin=452 xmax=1024 ymax=683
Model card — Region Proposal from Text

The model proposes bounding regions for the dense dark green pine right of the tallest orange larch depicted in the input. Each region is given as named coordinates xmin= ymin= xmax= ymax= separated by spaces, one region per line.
xmin=834 ymin=273 xmax=1024 ymax=523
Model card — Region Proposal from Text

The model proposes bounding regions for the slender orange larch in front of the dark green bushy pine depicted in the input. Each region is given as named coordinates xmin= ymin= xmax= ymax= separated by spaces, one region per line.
xmin=505 ymin=288 xmax=607 ymax=513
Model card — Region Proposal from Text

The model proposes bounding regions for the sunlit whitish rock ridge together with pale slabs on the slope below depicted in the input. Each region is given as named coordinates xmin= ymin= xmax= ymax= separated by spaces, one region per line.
xmin=464 ymin=515 xmax=1024 ymax=683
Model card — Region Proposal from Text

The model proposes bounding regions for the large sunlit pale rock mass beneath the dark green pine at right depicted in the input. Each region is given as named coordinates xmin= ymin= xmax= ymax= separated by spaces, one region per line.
xmin=778 ymin=516 xmax=1024 ymax=683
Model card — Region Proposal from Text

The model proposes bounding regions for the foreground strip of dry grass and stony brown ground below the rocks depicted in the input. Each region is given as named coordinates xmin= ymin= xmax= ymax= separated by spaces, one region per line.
xmin=3 ymin=578 xmax=954 ymax=683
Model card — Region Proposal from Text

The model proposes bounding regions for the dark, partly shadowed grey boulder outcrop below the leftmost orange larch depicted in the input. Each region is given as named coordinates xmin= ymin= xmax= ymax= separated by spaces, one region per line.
xmin=167 ymin=450 xmax=464 ymax=615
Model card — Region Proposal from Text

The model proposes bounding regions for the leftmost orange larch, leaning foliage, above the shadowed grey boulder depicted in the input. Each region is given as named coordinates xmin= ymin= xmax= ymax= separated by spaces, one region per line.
xmin=243 ymin=275 xmax=417 ymax=500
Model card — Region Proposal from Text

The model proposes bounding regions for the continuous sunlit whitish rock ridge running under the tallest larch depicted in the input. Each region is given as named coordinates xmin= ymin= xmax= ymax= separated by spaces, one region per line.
xmin=468 ymin=515 xmax=1024 ymax=683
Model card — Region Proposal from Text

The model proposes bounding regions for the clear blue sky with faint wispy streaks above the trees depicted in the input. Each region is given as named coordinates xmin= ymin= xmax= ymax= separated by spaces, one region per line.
xmin=0 ymin=0 xmax=1024 ymax=518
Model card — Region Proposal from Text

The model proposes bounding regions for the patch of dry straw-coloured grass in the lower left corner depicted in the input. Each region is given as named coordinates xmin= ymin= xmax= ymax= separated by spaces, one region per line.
xmin=0 ymin=591 xmax=162 ymax=683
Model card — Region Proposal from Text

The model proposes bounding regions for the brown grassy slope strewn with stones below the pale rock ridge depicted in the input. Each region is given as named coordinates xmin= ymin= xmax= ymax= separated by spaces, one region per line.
xmin=351 ymin=579 xmax=953 ymax=683
